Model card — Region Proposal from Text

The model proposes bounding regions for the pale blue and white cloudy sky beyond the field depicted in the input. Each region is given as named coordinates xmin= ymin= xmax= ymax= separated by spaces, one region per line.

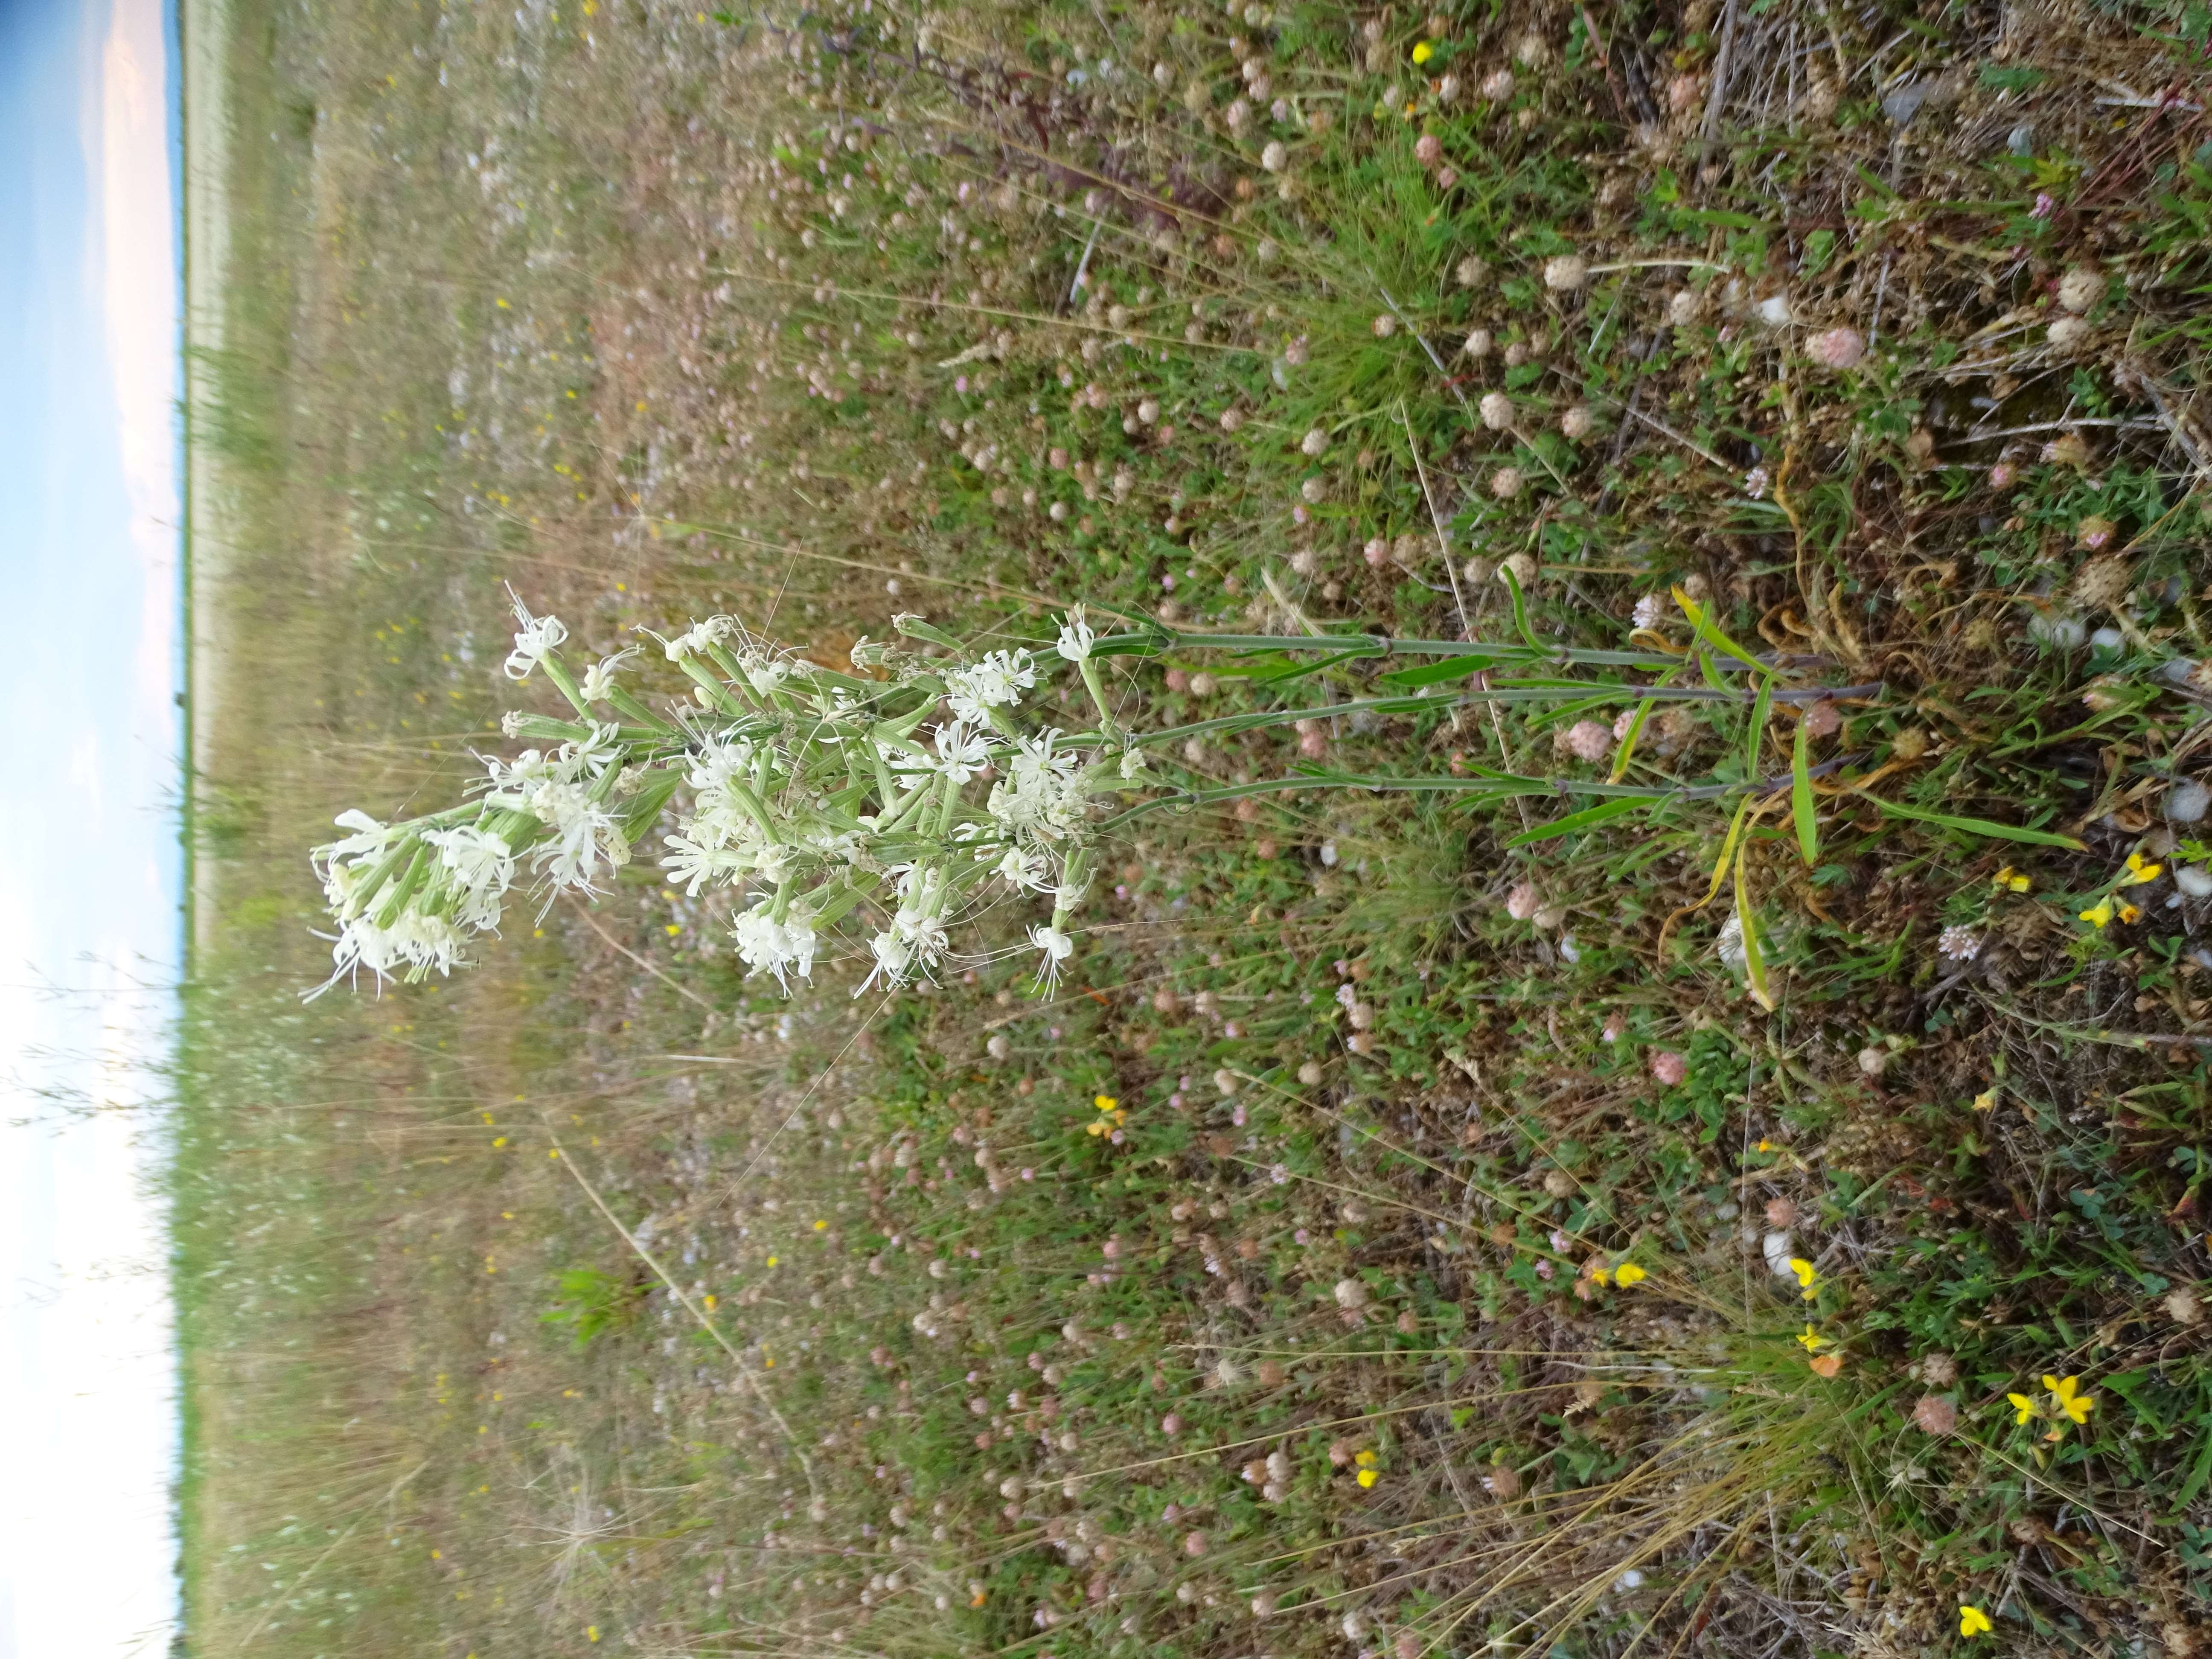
xmin=0 ymin=0 xmax=181 ymax=1659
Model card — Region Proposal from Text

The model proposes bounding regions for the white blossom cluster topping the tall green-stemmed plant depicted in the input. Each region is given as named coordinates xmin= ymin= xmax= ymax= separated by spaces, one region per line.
xmin=314 ymin=602 xmax=1146 ymax=991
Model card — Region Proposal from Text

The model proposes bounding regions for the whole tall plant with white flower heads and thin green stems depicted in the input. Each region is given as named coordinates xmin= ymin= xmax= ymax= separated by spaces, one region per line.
xmin=310 ymin=588 xmax=1878 ymax=995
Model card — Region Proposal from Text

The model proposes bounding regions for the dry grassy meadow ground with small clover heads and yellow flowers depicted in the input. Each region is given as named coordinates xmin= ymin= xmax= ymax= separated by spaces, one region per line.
xmin=175 ymin=0 xmax=2212 ymax=1659
